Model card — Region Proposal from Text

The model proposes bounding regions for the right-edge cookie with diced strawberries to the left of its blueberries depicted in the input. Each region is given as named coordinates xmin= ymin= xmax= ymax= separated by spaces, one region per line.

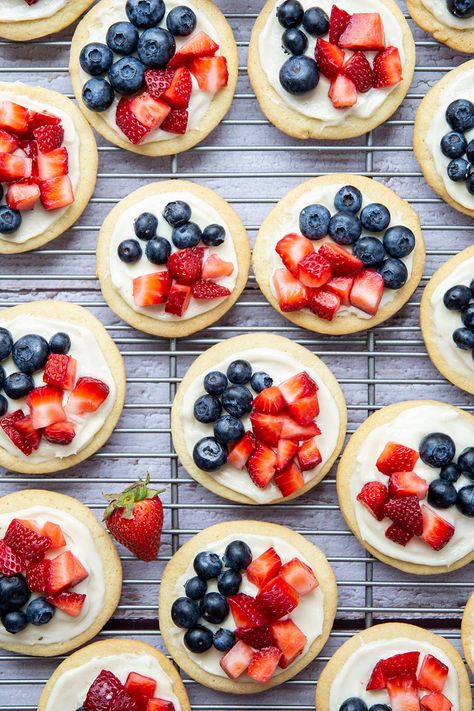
xmin=337 ymin=400 xmax=474 ymax=575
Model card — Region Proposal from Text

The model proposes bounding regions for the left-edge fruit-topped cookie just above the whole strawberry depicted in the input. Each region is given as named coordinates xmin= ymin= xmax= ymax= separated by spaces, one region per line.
xmin=0 ymin=301 xmax=125 ymax=474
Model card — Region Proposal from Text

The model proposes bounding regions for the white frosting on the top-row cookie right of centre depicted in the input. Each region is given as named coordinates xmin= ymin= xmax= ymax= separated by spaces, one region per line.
xmin=259 ymin=0 xmax=405 ymax=126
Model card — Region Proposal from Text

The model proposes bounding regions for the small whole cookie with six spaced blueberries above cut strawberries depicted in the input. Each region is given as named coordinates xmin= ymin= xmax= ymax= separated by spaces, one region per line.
xmin=97 ymin=180 xmax=250 ymax=337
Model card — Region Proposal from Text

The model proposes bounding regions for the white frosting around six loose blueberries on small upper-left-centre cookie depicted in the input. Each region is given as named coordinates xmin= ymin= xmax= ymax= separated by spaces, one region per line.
xmin=109 ymin=192 xmax=238 ymax=321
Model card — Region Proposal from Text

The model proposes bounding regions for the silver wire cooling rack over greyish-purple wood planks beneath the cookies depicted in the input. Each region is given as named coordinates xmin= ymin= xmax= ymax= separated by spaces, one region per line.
xmin=0 ymin=0 xmax=474 ymax=711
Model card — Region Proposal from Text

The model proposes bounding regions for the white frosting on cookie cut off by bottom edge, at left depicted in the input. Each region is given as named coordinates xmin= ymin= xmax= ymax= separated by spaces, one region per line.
xmin=45 ymin=642 xmax=181 ymax=711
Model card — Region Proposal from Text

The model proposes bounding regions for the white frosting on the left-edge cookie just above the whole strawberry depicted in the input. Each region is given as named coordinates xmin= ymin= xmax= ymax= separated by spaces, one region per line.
xmin=0 ymin=315 xmax=116 ymax=462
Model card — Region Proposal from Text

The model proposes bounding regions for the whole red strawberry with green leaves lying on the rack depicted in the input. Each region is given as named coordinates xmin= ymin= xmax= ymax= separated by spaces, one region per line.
xmin=104 ymin=476 xmax=163 ymax=561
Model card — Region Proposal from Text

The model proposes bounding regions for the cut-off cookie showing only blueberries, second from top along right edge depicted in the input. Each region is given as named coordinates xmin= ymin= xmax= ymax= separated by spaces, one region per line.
xmin=413 ymin=60 xmax=474 ymax=217
